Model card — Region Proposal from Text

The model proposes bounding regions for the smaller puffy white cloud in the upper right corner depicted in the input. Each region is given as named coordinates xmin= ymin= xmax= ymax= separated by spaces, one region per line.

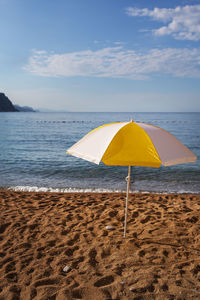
xmin=126 ymin=5 xmax=200 ymax=41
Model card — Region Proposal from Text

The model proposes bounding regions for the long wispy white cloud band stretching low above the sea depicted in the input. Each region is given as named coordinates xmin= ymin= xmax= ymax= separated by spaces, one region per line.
xmin=23 ymin=47 xmax=200 ymax=80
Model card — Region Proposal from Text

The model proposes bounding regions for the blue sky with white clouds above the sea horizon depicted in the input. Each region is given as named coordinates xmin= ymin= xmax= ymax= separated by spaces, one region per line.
xmin=0 ymin=0 xmax=200 ymax=112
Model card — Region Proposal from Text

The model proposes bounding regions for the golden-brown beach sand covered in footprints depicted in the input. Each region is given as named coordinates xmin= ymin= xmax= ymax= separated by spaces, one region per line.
xmin=0 ymin=189 xmax=200 ymax=300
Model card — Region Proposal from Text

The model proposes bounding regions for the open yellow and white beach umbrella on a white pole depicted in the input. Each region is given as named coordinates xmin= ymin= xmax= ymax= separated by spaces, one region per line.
xmin=67 ymin=120 xmax=197 ymax=237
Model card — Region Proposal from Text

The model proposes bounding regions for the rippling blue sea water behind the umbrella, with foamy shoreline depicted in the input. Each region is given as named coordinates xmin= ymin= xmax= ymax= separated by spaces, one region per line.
xmin=0 ymin=113 xmax=200 ymax=193
